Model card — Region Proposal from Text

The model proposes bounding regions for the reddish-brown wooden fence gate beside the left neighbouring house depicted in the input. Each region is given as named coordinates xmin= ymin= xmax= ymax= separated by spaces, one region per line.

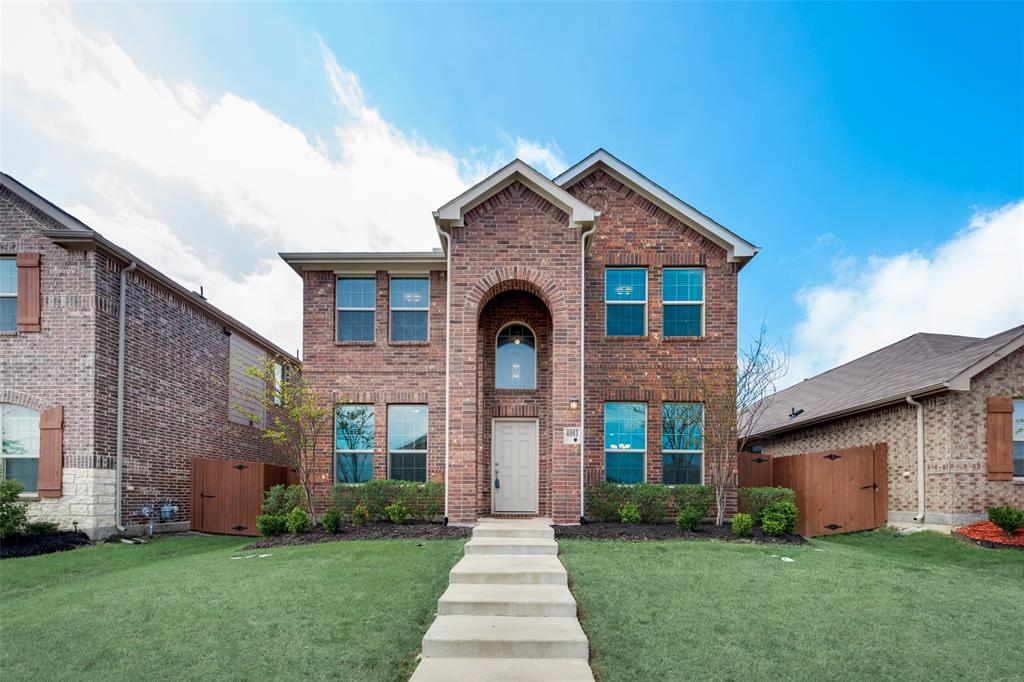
xmin=191 ymin=457 xmax=288 ymax=536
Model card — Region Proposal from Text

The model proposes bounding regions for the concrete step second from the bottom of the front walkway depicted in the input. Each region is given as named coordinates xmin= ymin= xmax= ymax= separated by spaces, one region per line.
xmin=423 ymin=615 xmax=588 ymax=660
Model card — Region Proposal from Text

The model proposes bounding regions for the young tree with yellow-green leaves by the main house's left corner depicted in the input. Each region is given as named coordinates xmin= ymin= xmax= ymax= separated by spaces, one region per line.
xmin=231 ymin=357 xmax=334 ymax=523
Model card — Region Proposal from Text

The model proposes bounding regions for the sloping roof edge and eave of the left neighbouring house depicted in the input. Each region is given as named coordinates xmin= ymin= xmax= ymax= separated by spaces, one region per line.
xmin=0 ymin=172 xmax=301 ymax=365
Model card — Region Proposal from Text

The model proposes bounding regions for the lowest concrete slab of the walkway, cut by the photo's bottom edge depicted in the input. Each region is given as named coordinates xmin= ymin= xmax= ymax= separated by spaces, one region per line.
xmin=409 ymin=658 xmax=594 ymax=682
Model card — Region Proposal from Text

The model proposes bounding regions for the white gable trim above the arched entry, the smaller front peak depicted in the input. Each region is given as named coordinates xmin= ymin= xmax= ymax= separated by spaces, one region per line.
xmin=434 ymin=159 xmax=600 ymax=228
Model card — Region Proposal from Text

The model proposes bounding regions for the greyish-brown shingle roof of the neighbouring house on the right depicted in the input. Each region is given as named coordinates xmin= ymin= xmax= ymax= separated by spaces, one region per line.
xmin=751 ymin=325 xmax=1024 ymax=438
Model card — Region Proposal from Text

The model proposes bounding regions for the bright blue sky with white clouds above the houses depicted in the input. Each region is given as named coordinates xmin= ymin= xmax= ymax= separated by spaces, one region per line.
xmin=0 ymin=3 xmax=1024 ymax=380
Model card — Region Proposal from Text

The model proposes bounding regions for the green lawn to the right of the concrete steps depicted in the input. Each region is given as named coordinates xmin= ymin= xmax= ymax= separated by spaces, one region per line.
xmin=559 ymin=531 xmax=1024 ymax=682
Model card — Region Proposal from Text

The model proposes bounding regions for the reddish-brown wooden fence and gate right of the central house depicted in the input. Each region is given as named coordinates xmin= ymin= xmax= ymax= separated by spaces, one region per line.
xmin=738 ymin=442 xmax=889 ymax=537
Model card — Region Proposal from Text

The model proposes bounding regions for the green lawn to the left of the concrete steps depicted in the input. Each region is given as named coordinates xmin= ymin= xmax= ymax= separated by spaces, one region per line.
xmin=0 ymin=537 xmax=463 ymax=682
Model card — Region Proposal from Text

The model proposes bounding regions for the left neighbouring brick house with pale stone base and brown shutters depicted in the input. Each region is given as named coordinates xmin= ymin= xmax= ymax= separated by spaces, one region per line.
xmin=0 ymin=174 xmax=297 ymax=537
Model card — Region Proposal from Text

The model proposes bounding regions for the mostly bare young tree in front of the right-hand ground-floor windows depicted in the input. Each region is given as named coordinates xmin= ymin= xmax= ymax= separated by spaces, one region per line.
xmin=680 ymin=324 xmax=788 ymax=525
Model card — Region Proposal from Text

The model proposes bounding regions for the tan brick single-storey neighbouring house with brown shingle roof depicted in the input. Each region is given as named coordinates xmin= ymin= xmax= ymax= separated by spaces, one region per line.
xmin=749 ymin=326 xmax=1024 ymax=525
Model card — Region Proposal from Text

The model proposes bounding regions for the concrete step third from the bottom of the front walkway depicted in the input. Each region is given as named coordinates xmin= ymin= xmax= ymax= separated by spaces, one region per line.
xmin=437 ymin=584 xmax=577 ymax=617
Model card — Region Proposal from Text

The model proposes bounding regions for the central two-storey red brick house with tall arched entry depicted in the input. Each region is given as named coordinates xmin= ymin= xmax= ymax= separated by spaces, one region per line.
xmin=282 ymin=150 xmax=757 ymax=523
